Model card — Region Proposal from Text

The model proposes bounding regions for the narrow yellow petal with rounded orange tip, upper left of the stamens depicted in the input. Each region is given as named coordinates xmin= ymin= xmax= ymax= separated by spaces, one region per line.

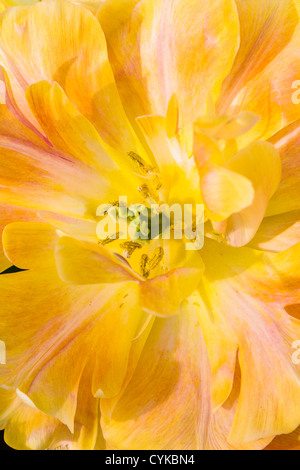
xmin=26 ymin=81 xmax=142 ymax=202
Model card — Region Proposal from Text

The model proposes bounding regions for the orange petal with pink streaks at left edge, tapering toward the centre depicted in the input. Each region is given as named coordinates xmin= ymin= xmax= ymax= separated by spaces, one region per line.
xmin=0 ymin=105 xmax=99 ymax=215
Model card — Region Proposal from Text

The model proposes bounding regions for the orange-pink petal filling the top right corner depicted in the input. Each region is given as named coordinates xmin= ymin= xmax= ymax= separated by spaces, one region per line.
xmin=219 ymin=0 xmax=300 ymax=142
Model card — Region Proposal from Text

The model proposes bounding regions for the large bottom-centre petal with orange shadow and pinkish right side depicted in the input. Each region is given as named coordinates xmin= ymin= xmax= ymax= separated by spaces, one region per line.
xmin=101 ymin=313 xmax=211 ymax=450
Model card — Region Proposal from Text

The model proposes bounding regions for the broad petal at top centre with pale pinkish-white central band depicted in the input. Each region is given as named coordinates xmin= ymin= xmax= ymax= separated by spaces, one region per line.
xmin=98 ymin=0 xmax=239 ymax=145
